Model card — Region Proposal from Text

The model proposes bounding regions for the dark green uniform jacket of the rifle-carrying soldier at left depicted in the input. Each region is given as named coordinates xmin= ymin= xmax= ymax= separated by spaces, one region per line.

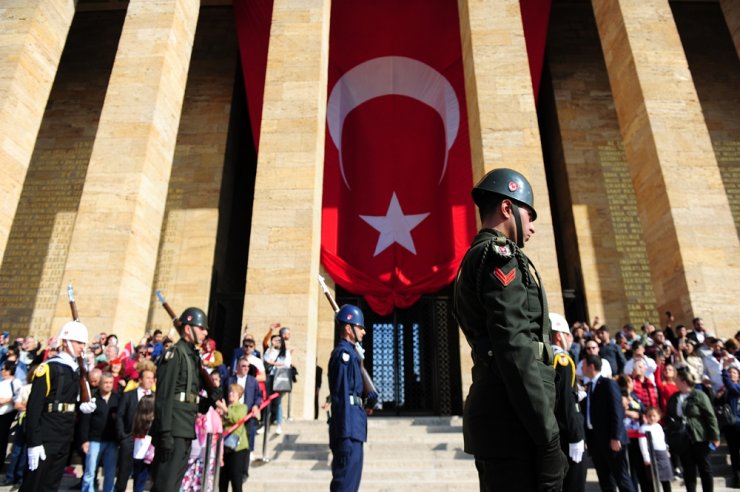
xmin=152 ymin=338 xmax=217 ymax=439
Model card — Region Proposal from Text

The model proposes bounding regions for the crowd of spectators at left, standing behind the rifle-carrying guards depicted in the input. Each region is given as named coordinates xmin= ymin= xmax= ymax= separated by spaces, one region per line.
xmin=0 ymin=324 xmax=295 ymax=492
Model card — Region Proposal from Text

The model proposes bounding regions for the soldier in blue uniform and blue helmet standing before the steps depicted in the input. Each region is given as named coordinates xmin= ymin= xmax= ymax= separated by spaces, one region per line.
xmin=329 ymin=304 xmax=367 ymax=492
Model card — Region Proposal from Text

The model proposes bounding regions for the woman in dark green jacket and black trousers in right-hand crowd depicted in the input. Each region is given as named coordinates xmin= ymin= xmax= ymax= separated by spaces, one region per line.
xmin=666 ymin=369 xmax=719 ymax=492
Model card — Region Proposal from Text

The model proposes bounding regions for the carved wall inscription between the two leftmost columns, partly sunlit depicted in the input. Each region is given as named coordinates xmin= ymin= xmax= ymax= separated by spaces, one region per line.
xmin=0 ymin=140 xmax=92 ymax=336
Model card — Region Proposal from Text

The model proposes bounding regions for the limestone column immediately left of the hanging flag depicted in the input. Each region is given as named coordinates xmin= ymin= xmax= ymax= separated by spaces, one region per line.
xmin=244 ymin=0 xmax=331 ymax=418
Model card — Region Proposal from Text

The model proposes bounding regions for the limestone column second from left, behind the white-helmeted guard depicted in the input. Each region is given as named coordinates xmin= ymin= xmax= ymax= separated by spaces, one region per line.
xmin=52 ymin=0 xmax=200 ymax=342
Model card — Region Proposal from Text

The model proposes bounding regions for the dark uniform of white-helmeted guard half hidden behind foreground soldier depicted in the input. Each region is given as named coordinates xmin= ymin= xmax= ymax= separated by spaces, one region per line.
xmin=553 ymin=345 xmax=586 ymax=492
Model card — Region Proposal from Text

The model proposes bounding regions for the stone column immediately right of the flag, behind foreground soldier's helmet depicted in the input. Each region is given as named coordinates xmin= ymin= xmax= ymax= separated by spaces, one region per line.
xmin=458 ymin=0 xmax=563 ymax=313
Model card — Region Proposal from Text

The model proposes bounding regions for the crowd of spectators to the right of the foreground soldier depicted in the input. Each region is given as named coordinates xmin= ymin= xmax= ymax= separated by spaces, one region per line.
xmin=553 ymin=312 xmax=740 ymax=492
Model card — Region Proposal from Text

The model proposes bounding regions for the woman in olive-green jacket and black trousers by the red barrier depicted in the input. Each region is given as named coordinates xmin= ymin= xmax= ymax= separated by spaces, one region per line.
xmin=218 ymin=383 xmax=249 ymax=492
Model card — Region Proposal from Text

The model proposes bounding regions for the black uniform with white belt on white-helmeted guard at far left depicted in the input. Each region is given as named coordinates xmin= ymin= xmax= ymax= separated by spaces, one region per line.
xmin=21 ymin=352 xmax=80 ymax=492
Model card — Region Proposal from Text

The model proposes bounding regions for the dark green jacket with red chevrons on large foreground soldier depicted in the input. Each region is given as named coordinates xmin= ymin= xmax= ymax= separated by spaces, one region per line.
xmin=454 ymin=229 xmax=559 ymax=458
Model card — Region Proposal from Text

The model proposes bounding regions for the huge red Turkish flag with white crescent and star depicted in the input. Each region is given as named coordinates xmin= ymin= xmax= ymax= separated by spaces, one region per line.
xmin=321 ymin=0 xmax=475 ymax=315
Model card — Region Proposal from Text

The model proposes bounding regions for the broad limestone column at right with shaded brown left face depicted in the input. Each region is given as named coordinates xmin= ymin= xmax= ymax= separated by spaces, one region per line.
xmin=593 ymin=0 xmax=740 ymax=336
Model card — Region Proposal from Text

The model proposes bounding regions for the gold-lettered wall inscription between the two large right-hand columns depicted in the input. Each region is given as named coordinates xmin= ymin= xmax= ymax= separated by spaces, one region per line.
xmin=598 ymin=142 xmax=658 ymax=323
